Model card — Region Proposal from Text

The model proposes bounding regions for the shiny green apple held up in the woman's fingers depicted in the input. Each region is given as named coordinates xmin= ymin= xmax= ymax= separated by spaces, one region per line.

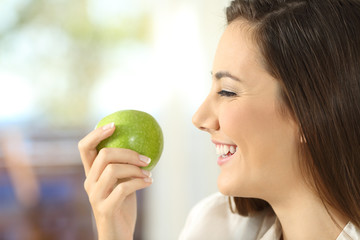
xmin=96 ymin=110 xmax=164 ymax=171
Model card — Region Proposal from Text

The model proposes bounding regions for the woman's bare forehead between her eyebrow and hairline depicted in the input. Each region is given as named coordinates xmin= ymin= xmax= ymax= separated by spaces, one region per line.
xmin=213 ymin=20 xmax=265 ymax=75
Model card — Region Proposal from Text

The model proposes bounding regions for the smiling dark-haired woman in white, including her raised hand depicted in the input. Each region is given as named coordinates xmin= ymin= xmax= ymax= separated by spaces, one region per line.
xmin=79 ymin=0 xmax=360 ymax=240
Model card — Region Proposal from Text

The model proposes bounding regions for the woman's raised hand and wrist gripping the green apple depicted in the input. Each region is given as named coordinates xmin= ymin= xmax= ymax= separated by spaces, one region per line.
xmin=79 ymin=124 xmax=152 ymax=240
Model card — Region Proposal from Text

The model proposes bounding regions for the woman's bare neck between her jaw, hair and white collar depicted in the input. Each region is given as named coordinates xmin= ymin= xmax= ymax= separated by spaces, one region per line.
xmin=269 ymin=183 xmax=349 ymax=240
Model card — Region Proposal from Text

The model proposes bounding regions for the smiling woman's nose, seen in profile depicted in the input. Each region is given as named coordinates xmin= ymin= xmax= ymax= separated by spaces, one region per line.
xmin=192 ymin=95 xmax=220 ymax=133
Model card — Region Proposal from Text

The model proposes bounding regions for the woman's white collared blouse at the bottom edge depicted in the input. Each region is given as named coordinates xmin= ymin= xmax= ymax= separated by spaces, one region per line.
xmin=179 ymin=193 xmax=360 ymax=240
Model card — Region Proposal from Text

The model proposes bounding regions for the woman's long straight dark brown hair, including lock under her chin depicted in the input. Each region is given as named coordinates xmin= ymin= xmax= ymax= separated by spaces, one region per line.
xmin=226 ymin=0 xmax=360 ymax=227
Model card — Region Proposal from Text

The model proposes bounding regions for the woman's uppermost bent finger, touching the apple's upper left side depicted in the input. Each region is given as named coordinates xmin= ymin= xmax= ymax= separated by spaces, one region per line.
xmin=78 ymin=123 xmax=115 ymax=176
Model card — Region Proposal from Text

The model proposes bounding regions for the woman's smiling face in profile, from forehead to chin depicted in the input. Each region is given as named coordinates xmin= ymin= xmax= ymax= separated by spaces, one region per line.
xmin=193 ymin=21 xmax=300 ymax=199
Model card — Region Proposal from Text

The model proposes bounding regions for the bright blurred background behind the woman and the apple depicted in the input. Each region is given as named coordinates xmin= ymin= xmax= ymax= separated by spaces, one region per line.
xmin=0 ymin=0 xmax=229 ymax=240
